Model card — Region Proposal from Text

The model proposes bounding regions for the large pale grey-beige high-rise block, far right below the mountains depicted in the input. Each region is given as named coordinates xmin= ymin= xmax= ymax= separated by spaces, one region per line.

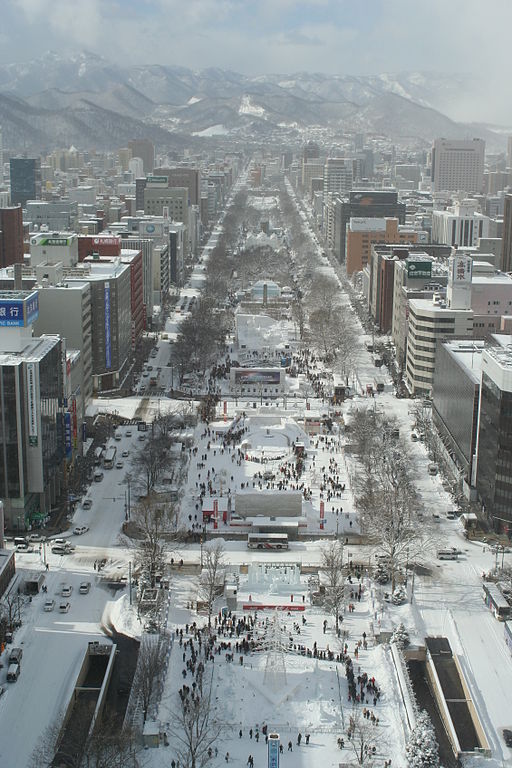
xmin=432 ymin=139 xmax=485 ymax=193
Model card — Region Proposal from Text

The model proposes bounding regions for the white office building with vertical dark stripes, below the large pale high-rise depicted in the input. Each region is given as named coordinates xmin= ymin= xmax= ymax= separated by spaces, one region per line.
xmin=432 ymin=200 xmax=489 ymax=248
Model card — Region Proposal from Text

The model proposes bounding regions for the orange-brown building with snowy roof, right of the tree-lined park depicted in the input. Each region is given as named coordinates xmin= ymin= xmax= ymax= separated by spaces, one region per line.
xmin=346 ymin=217 xmax=418 ymax=275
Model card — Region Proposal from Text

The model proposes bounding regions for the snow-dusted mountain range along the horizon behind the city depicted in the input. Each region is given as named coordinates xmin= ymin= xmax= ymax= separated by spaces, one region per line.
xmin=0 ymin=52 xmax=503 ymax=151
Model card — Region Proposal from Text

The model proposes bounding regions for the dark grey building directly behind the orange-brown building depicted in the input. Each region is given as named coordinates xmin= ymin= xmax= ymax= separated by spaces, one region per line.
xmin=329 ymin=190 xmax=405 ymax=261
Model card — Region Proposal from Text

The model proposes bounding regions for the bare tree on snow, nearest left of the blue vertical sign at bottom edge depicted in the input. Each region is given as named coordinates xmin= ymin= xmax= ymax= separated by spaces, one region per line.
xmin=171 ymin=669 xmax=222 ymax=768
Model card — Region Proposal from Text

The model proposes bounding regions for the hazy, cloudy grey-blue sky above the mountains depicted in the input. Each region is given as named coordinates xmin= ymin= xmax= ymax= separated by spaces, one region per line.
xmin=0 ymin=0 xmax=512 ymax=120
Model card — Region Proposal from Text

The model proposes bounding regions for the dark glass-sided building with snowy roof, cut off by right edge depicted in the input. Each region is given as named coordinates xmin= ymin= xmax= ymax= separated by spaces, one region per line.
xmin=476 ymin=334 xmax=512 ymax=535
